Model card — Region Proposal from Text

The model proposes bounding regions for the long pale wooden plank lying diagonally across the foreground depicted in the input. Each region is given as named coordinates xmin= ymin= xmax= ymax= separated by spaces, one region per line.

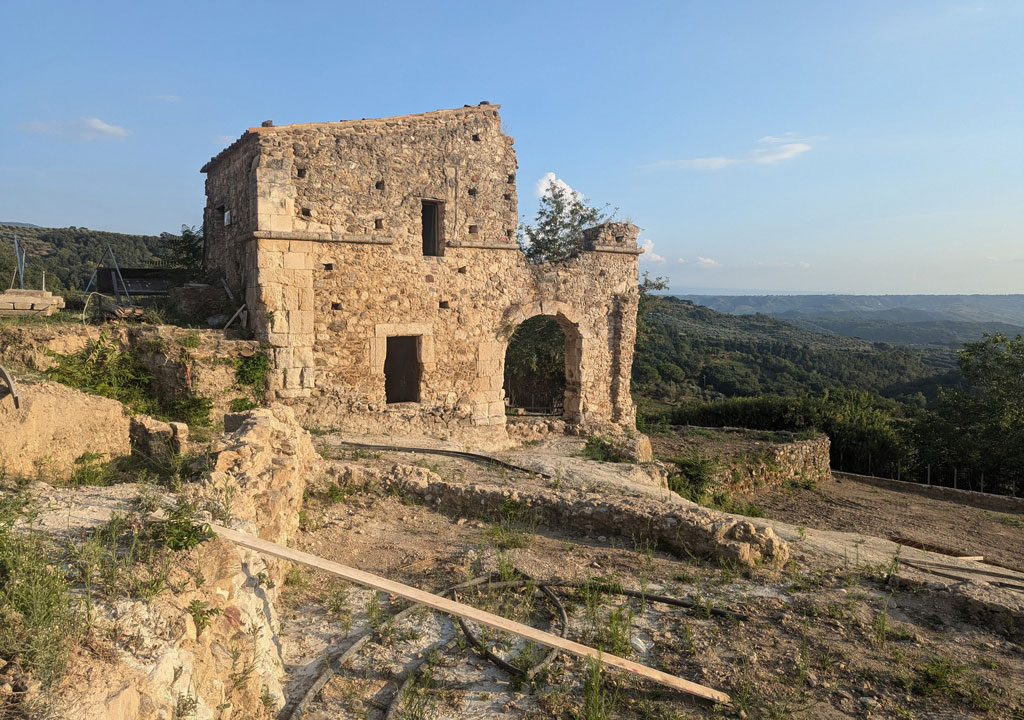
xmin=210 ymin=524 xmax=730 ymax=703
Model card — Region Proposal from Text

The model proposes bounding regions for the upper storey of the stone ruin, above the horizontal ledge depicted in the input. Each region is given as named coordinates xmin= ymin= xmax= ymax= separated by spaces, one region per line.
xmin=203 ymin=103 xmax=518 ymax=278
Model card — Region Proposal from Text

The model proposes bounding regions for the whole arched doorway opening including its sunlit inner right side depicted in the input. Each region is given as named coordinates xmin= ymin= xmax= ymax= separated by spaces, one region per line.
xmin=503 ymin=313 xmax=583 ymax=422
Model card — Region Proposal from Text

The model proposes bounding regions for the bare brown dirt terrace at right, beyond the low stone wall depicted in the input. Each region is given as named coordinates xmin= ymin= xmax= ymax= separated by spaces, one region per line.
xmin=743 ymin=473 xmax=1024 ymax=573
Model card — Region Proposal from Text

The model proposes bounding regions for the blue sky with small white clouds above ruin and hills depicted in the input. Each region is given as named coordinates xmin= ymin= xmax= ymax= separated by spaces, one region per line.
xmin=0 ymin=0 xmax=1024 ymax=293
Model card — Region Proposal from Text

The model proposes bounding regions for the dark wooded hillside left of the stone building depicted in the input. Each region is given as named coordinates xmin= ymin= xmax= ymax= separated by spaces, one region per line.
xmin=0 ymin=225 xmax=178 ymax=293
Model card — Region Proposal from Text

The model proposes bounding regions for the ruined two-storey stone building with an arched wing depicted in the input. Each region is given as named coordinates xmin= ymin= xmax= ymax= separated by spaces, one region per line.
xmin=203 ymin=103 xmax=642 ymax=446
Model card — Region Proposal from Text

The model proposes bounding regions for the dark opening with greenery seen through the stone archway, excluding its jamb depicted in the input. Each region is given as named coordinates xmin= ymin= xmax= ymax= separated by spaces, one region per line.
xmin=505 ymin=315 xmax=567 ymax=415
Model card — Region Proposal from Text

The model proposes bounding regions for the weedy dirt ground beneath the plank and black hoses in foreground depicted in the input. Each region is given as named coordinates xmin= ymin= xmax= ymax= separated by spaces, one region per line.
xmin=283 ymin=444 xmax=1024 ymax=720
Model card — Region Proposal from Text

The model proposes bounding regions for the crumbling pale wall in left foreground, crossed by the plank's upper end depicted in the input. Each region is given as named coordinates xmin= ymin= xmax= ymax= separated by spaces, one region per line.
xmin=24 ymin=407 xmax=323 ymax=720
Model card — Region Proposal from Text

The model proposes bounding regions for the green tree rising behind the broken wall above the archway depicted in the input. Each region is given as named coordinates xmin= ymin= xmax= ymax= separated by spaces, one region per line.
xmin=519 ymin=178 xmax=614 ymax=262
